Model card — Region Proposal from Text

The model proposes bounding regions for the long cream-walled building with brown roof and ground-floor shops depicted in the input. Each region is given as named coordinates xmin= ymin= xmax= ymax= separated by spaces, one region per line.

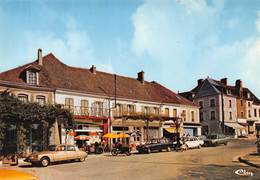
xmin=0 ymin=50 xmax=201 ymax=148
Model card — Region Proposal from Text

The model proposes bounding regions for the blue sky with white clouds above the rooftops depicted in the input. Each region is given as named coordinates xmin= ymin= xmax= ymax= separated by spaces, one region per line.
xmin=0 ymin=0 xmax=260 ymax=97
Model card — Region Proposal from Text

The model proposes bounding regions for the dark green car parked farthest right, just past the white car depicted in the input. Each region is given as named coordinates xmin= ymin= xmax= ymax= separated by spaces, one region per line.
xmin=204 ymin=134 xmax=229 ymax=146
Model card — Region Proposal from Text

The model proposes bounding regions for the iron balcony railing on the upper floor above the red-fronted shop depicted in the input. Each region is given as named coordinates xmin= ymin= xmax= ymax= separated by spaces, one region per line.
xmin=62 ymin=105 xmax=109 ymax=117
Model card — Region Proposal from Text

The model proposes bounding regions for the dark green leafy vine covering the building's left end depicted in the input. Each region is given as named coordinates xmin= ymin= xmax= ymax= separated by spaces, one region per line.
xmin=0 ymin=91 xmax=73 ymax=153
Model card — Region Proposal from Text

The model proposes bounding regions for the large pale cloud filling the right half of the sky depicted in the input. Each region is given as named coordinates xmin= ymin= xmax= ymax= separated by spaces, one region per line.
xmin=132 ymin=0 xmax=260 ymax=95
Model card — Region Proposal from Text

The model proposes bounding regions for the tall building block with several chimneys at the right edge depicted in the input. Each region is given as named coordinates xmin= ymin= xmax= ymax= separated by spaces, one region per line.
xmin=181 ymin=78 xmax=259 ymax=136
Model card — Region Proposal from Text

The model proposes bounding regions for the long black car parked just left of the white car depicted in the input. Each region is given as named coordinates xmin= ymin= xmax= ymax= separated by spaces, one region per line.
xmin=136 ymin=139 xmax=175 ymax=153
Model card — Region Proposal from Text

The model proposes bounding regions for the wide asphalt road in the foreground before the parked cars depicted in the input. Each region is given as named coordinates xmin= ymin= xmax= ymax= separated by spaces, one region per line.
xmin=0 ymin=139 xmax=260 ymax=180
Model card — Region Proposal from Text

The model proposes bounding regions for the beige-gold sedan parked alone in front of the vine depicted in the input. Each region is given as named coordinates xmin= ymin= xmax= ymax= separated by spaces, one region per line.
xmin=24 ymin=145 xmax=88 ymax=167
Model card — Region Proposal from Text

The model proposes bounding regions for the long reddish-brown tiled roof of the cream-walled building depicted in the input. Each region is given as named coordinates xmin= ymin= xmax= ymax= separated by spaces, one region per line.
xmin=0 ymin=53 xmax=195 ymax=106
